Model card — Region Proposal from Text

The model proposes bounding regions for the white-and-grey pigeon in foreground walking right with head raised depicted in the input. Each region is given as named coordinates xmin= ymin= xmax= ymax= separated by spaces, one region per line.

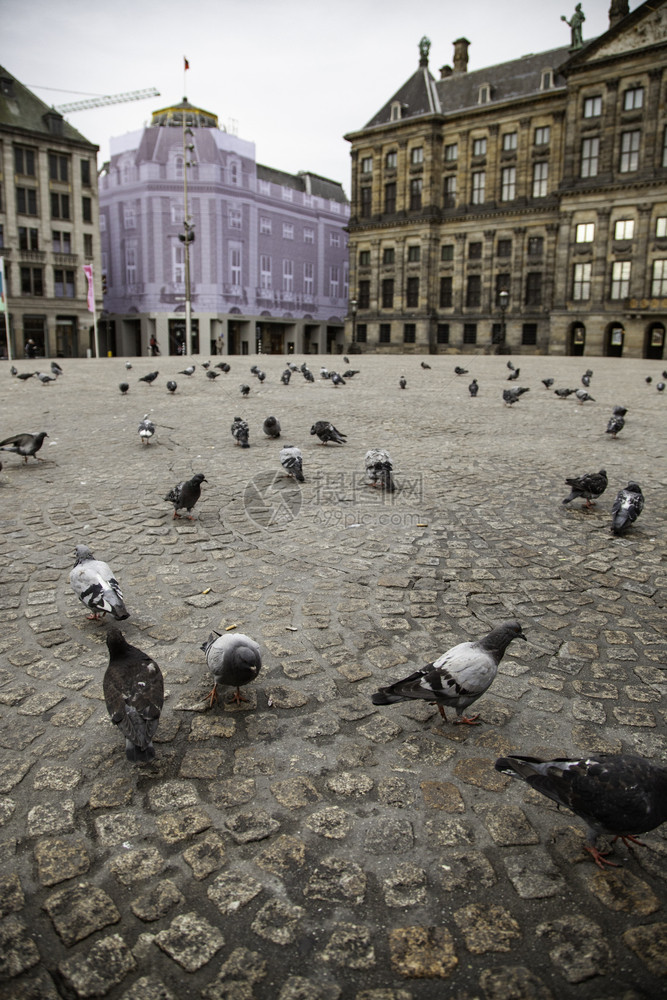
xmin=371 ymin=621 xmax=526 ymax=725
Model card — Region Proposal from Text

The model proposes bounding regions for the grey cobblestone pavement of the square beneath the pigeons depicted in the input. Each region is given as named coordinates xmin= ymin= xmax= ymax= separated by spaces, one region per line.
xmin=0 ymin=356 xmax=667 ymax=1000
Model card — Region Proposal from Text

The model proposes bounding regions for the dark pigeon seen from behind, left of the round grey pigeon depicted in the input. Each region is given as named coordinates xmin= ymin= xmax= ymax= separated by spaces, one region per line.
xmin=102 ymin=625 xmax=164 ymax=761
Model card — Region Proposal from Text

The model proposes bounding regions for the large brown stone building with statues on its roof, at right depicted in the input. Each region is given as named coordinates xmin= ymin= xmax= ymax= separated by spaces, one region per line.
xmin=346 ymin=0 xmax=667 ymax=358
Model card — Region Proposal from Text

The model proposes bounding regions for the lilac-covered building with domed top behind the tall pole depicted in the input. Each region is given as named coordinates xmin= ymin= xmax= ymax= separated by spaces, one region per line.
xmin=100 ymin=100 xmax=349 ymax=355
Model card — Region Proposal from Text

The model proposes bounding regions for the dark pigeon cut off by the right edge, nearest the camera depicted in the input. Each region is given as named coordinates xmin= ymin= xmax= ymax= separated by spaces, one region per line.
xmin=495 ymin=753 xmax=667 ymax=870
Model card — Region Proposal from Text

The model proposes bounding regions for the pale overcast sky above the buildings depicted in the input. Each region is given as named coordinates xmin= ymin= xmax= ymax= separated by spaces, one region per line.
xmin=5 ymin=0 xmax=639 ymax=194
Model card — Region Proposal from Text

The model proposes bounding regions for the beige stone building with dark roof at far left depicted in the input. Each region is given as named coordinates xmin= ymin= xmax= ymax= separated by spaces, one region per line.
xmin=0 ymin=67 xmax=102 ymax=357
